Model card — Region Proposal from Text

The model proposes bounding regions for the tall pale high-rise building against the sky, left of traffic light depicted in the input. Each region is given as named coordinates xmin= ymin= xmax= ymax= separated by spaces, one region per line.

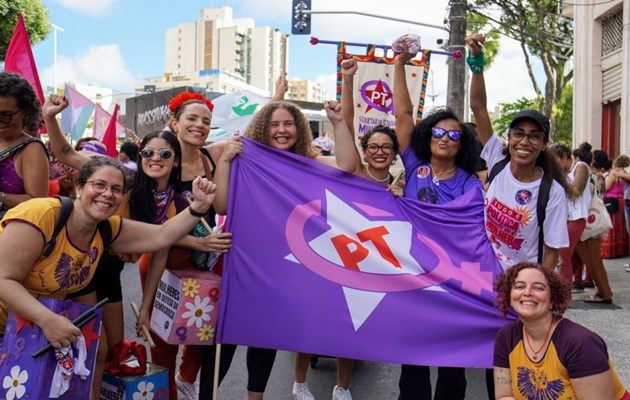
xmin=165 ymin=6 xmax=288 ymax=96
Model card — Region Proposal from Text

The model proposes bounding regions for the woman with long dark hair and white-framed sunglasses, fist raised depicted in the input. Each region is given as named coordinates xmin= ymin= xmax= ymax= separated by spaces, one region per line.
xmin=44 ymin=95 xmax=201 ymax=398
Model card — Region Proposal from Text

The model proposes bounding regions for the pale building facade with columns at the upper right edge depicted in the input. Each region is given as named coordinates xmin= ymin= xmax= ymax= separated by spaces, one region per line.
xmin=563 ymin=0 xmax=630 ymax=157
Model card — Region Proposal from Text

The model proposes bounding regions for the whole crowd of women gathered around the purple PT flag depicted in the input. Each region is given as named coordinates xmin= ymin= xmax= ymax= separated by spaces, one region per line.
xmin=0 ymin=31 xmax=630 ymax=400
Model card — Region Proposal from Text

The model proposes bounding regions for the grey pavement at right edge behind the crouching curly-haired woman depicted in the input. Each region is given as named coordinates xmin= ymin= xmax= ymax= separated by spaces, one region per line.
xmin=565 ymin=258 xmax=630 ymax=388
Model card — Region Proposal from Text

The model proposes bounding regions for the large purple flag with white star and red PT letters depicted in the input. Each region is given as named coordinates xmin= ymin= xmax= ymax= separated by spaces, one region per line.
xmin=217 ymin=138 xmax=506 ymax=368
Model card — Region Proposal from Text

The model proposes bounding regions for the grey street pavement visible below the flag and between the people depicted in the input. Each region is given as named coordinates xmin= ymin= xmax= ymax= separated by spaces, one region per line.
xmin=122 ymin=258 xmax=630 ymax=400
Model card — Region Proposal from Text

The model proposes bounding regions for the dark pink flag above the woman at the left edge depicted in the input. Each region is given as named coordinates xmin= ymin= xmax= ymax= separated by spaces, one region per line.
xmin=4 ymin=13 xmax=46 ymax=133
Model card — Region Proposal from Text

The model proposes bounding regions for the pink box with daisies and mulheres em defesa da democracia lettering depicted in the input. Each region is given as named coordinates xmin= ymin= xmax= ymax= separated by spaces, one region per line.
xmin=151 ymin=269 xmax=221 ymax=345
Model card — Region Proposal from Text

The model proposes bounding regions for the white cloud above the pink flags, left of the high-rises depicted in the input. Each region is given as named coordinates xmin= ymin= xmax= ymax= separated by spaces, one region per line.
xmin=40 ymin=44 xmax=136 ymax=92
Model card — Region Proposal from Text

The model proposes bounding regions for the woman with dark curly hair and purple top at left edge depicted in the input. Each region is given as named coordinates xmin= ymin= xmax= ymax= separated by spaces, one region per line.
xmin=0 ymin=71 xmax=48 ymax=218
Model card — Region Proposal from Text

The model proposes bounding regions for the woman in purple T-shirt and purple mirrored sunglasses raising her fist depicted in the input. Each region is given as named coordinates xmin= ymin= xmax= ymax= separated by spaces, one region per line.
xmin=394 ymin=40 xmax=483 ymax=400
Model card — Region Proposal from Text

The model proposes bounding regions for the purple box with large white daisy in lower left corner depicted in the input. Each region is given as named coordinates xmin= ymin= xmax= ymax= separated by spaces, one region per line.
xmin=0 ymin=299 xmax=101 ymax=400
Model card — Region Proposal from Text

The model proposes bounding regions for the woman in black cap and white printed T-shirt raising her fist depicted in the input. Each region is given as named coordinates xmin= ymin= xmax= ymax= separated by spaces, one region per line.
xmin=466 ymin=34 xmax=571 ymax=399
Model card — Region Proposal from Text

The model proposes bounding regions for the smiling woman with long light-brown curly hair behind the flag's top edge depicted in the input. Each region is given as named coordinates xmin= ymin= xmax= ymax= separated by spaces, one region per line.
xmin=214 ymin=95 xmax=356 ymax=400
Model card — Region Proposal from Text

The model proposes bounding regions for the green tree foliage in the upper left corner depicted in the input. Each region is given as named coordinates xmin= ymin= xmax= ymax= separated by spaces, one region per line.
xmin=0 ymin=0 xmax=50 ymax=60
